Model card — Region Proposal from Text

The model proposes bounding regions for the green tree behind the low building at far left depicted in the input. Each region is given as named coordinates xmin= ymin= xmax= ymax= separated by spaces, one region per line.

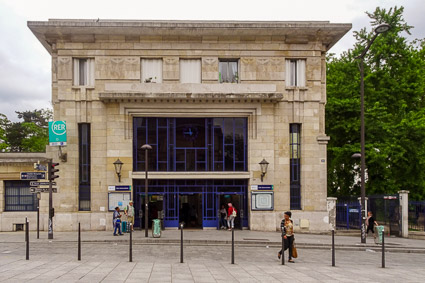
xmin=0 ymin=109 xmax=52 ymax=152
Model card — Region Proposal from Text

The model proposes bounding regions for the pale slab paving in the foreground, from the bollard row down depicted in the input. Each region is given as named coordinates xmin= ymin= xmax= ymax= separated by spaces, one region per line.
xmin=0 ymin=242 xmax=425 ymax=283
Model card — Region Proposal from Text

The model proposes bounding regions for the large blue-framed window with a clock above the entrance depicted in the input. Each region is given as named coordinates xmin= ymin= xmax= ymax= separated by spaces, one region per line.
xmin=133 ymin=118 xmax=247 ymax=171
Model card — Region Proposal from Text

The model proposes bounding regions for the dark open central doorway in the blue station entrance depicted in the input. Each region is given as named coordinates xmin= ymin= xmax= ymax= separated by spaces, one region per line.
xmin=179 ymin=193 xmax=202 ymax=228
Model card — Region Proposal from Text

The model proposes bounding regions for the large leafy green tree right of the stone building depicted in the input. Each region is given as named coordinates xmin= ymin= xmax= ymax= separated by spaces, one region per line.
xmin=326 ymin=7 xmax=425 ymax=199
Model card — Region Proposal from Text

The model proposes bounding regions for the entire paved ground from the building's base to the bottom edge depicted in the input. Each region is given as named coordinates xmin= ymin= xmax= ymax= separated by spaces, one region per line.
xmin=0 ymin=231 xmax=425 ymax=282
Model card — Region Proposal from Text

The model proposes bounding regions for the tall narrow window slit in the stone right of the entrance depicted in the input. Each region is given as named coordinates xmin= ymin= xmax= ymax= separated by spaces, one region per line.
xmin=289 ymin=124 xmax=301 ymax=210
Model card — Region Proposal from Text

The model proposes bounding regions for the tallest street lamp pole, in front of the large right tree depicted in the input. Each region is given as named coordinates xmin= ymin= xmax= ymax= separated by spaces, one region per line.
xmin=355 ymin=24 xmax=390 ymax=243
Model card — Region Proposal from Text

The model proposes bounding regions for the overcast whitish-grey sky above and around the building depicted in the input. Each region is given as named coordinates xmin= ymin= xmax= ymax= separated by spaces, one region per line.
xmin=0 ymin=0 xmax=425 ymax=120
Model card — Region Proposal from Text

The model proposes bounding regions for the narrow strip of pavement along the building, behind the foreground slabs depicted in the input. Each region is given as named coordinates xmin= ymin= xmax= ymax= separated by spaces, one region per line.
xmin=0 ymin=229 xmax=425 ymax=253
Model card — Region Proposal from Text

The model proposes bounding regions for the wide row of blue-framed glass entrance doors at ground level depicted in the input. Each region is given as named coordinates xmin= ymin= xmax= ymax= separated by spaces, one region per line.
xmin=133 ymin=179 xmax=248 ymax=229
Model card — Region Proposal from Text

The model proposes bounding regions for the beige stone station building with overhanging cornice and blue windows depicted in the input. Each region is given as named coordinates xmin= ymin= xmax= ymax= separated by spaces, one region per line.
xmin=3 ymin=20 xmax=351 ymax=231
